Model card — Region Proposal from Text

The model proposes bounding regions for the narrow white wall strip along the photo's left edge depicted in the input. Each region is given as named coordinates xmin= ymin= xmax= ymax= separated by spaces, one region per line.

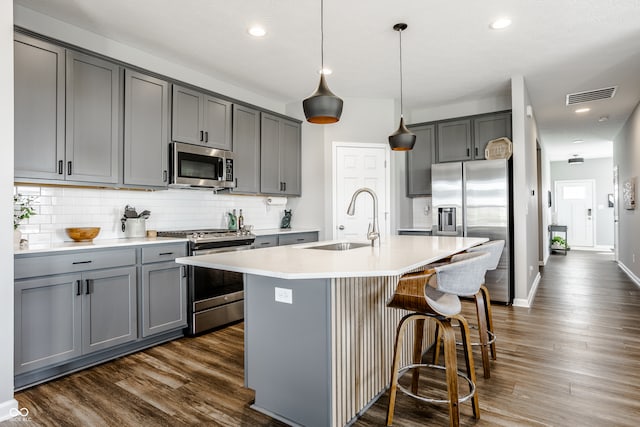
xmin=0 ymin=1 xmax=18 ymax=420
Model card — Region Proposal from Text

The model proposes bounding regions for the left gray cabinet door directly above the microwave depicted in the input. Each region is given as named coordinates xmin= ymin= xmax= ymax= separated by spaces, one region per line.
xmin=171 ymin=85 xmax=204 ymax=145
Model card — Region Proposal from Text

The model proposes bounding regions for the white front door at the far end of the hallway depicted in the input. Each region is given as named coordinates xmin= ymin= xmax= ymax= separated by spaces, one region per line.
xmin=555 ymin=180 xmax=595 ymax=247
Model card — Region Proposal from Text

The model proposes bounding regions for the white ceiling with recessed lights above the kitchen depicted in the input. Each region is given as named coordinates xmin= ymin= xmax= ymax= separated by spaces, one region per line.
xmin=14 ymin=0 xmax=640 ymax=160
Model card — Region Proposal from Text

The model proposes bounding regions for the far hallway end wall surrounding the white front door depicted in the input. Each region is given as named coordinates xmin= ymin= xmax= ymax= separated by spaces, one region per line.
xmin=551 ymin=157 xmax=613 ymax=246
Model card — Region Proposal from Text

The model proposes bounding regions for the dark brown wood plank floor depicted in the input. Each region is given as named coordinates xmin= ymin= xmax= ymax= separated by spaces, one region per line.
xmin=2 ymin=251 xmax=640 ymax=427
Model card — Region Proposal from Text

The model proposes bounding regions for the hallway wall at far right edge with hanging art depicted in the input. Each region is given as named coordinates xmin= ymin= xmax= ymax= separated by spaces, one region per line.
xmin=613 ymin=104 xmax=640 ymax=278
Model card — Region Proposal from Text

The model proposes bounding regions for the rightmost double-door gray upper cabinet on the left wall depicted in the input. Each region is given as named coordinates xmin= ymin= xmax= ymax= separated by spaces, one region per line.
xmin=260 ymin=113 xmax=301 ymax=196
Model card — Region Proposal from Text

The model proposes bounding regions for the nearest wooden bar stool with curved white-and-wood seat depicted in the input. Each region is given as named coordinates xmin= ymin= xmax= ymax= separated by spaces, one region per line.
xmin=387 ymin=252 xmax=489 ymax=426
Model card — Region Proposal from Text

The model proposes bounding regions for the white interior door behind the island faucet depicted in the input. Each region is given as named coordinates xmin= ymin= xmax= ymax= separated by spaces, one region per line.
xmin=333 ymin=143 xmax=390 ymax=240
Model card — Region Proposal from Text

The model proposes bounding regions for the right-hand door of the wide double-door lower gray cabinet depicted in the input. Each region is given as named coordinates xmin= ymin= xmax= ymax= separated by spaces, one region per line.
xmin=82 ymin=267 xmax=138 ymax=354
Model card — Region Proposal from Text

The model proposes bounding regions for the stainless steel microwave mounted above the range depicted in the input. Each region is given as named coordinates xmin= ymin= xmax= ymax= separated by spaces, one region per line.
xmin=169 ymin=142 xmax=235 ymax=188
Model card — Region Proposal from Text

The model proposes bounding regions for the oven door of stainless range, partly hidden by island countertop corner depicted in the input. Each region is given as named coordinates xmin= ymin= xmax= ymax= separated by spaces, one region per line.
xmin=189 ymin=245 xmax=253 ymax=312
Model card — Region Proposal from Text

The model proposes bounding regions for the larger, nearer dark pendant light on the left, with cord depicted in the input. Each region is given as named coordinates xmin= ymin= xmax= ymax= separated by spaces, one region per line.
xmin=302 ymin=0 xmax=342 ymax=125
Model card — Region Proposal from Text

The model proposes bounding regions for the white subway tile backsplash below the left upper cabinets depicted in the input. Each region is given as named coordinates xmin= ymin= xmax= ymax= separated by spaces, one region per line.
xmin=14 ymin=186 xmax=284 ymax=244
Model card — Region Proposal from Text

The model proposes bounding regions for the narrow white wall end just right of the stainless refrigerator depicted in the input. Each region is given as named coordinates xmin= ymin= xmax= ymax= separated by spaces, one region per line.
xmin=511 ymin=76 xmax=540 ymax=306
